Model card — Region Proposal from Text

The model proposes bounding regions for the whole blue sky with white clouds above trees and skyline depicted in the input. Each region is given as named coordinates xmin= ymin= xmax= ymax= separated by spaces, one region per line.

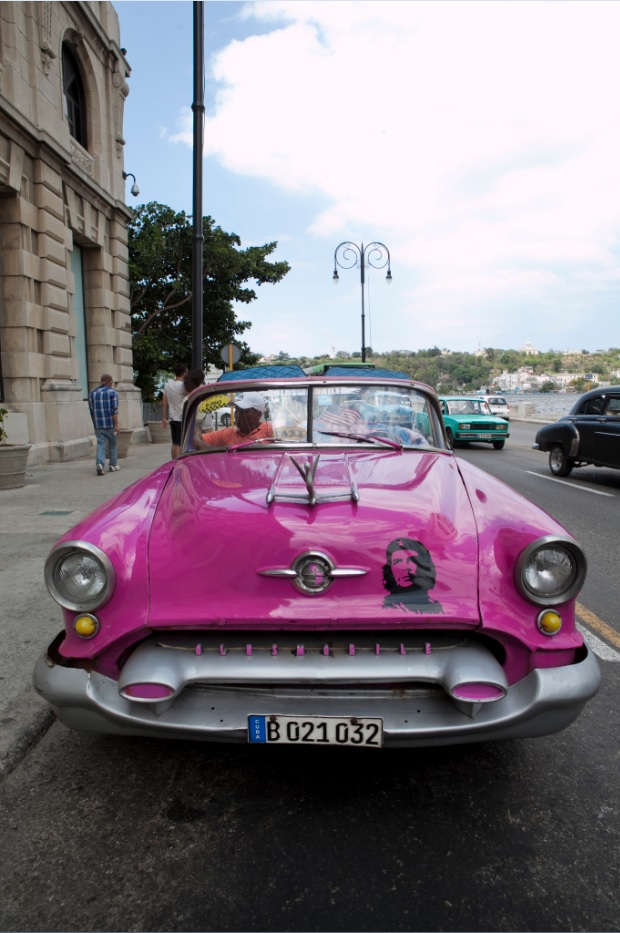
xmin=114 ymin=0 xmax=620 ymax=356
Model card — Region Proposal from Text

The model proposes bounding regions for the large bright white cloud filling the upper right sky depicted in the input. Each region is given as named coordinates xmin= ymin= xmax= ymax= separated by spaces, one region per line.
xmin=171 ymin=0 xmax=620 ymax=350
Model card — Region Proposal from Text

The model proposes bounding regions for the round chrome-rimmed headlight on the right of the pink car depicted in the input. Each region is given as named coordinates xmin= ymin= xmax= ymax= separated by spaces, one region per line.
xmin=515 ymin=535 xmax=587 ymax=606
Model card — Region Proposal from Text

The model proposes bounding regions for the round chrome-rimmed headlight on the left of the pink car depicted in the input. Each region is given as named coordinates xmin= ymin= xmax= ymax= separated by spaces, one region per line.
xmin=45 ymin=541 xmax=115 ymax=612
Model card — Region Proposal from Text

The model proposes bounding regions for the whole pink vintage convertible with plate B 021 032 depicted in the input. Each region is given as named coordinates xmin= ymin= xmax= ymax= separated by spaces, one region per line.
xmin=34 ymin=366 xmax=600 ymax=747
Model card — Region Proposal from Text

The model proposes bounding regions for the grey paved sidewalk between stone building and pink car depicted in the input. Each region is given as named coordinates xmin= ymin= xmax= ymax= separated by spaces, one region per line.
xmin=0 ymin=443 xmax=170 ymax=780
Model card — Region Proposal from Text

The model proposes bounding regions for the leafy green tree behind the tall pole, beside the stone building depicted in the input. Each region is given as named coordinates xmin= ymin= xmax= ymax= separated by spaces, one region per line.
xmin=128 ymin=202 xmax=290 ymax=400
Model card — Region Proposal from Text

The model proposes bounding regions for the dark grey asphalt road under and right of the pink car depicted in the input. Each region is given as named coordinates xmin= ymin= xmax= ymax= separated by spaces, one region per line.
xmin=0 ymin=425 xmax=620 ymax=933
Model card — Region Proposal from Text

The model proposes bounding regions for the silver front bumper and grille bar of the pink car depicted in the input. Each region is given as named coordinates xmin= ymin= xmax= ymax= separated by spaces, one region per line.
xmin=34 ymin=633 xmax=600 ymax=747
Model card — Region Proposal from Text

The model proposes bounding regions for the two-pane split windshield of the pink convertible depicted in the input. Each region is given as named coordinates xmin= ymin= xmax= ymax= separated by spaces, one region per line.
xmin=183 ymin=383 xmax=445 ymax=452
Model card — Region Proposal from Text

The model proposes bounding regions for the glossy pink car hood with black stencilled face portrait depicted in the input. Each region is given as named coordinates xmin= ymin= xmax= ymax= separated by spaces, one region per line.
xmin=148 ymin=450 xmax=480 ymax=628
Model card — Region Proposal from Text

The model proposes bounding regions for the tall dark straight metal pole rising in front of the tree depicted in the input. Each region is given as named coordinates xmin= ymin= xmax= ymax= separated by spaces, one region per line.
xmin=192 ymin=0 xmax=205 ymax=369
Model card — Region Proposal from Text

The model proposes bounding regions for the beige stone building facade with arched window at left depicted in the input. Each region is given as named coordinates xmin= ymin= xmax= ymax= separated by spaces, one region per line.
xmin=0 ymin=2 xmax=147 ymax=465
